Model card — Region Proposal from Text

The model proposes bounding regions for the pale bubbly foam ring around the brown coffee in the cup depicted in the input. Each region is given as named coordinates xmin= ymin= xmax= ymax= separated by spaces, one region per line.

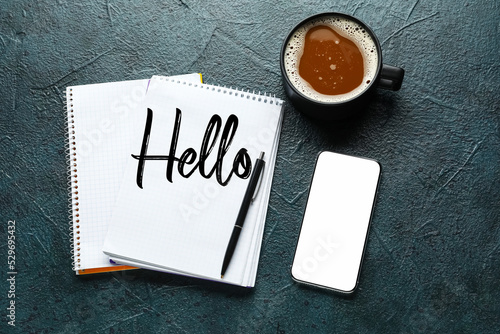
xmin=284 ymin=15 xmax=379 ymax=103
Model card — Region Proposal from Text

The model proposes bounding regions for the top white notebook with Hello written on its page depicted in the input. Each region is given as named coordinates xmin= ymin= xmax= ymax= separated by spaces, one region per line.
xmin=103 ymin=77 xmax=282 ymax=287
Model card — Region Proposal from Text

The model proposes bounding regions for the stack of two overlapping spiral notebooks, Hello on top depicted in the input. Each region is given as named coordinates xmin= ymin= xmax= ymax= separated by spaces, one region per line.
xmin=66 ymin=73 xmax=282 ymax=287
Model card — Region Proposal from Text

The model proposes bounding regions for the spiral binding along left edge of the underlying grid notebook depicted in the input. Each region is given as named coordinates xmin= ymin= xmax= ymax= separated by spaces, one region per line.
xmin=64 ymin=88 xmax=80 ymax=271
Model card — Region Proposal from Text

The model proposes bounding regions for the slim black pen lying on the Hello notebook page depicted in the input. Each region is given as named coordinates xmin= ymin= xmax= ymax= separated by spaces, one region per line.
xmin=220 ymin=152 xmax=265 ymax=278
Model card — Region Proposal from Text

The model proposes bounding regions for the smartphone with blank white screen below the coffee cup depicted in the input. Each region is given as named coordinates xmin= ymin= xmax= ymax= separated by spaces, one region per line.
xmin=292 ymin=151 xmax=381 ymax=293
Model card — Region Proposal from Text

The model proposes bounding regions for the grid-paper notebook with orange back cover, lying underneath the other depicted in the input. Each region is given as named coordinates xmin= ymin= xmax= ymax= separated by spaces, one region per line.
xmin=66 ymin=73 xmax=201 ymax=275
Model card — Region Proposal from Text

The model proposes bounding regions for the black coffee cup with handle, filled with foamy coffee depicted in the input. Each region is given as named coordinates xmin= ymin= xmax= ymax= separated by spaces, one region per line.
xmin=281 ymin=12 xmax=404 ymax=120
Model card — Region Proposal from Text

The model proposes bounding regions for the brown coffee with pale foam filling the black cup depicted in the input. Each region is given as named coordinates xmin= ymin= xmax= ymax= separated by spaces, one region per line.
xmin=283 ymin=14 xmax=379 ymax=103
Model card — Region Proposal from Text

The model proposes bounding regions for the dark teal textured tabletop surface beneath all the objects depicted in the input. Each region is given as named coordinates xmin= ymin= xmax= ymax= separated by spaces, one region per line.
xmin=0 ymin=0 xmax=500 ymax=333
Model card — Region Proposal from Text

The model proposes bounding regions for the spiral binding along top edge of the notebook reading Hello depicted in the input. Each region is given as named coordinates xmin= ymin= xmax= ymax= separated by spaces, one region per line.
xmin=153 ymin=75 xmax=283 ymax=105
